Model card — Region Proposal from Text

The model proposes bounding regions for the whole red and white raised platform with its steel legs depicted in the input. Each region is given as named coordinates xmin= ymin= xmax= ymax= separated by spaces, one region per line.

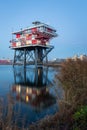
xmin=10 ymin=21 xmax=57 ymax=67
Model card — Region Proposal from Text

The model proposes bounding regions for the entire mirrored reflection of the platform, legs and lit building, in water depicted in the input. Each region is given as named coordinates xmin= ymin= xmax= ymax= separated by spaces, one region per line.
xmin=12 ymin=68 xmax=56 ymax=110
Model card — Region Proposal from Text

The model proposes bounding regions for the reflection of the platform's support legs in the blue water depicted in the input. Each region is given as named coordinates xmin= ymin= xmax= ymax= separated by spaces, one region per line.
xmin=14 ymin=67 xmax=49 ymax=87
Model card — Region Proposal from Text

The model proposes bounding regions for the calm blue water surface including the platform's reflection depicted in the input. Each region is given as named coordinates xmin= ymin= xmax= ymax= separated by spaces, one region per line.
xmin=0 ymin=65 xmax=62 ymax=127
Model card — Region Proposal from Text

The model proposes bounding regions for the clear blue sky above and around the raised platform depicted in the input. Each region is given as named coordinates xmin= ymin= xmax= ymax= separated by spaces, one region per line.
xmin=0 ymin=0 xmax=87 ymax=59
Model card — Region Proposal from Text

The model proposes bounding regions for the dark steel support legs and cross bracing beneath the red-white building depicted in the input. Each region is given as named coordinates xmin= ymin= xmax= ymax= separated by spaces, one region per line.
xmin=13 ymin=46 xmax=54 ymax=67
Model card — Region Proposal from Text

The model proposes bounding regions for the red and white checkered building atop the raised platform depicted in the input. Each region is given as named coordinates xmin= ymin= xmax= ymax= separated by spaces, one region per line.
xmin=11 ymin=21 xmax=56 ymax=47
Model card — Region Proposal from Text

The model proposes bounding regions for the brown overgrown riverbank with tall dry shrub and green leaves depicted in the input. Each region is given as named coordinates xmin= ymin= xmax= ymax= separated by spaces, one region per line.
xmin=29 ymin=59 xmax=87 ymax=130
